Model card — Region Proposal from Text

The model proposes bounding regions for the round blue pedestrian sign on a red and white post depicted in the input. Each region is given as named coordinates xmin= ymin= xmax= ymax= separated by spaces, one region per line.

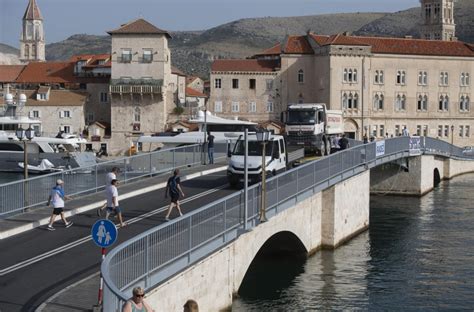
xmin=91 ymin=219 xmax=118 ymax=307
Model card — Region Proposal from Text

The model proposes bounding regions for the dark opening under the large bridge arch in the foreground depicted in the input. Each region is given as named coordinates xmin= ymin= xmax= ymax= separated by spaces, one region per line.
xmin=238 ymin=231 xmax=308 ymax=297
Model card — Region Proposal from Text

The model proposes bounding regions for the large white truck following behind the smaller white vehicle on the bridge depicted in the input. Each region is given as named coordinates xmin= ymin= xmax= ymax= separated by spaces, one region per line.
xmin=284 ymin=103 xmax=344 ymax=155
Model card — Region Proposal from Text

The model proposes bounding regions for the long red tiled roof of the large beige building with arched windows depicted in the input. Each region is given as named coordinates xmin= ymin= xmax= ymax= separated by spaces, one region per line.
xmin=311 ymin=34 xmax=474 ymax=57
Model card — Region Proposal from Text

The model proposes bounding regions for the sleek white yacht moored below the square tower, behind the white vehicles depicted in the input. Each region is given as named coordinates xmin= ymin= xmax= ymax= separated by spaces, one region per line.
xmin=138 ymin=111 xmax=257 ymax=148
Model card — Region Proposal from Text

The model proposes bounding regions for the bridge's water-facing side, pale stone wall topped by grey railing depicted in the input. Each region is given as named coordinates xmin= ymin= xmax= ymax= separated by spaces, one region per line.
xmin=101 ymin=137 xmax=474 ymax=311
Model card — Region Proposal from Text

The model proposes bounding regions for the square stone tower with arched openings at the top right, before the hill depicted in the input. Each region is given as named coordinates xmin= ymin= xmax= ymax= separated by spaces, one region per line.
xmin=420 ymin=0 xmax=456 ymax=41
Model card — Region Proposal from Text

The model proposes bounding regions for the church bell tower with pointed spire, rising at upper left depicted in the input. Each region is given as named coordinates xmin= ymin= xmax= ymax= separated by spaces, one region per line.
xmin=20 ymin=0 xmax=46 ymax=63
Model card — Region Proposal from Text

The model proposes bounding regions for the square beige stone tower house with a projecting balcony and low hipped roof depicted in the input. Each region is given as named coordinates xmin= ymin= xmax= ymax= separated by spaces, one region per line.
xmin=108 ymin=19 xmax=171 ymax=154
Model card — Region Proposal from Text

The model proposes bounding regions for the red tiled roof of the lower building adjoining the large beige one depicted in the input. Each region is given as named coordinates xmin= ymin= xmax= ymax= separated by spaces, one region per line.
xmin=211 ymin=59 xmax=280 ymax=72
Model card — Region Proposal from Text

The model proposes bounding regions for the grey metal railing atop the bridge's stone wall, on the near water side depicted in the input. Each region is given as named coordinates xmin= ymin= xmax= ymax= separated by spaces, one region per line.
xmin=101 ymin=137 xmax=473 ymax=311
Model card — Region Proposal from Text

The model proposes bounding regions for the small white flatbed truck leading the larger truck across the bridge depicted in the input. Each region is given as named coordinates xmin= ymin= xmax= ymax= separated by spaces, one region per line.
xmin=227 ymin=133 xmax=304 ymax=187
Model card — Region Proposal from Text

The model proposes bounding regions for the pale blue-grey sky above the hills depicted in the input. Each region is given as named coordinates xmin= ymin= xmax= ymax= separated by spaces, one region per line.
xmin=0 ymin=0 xmax=420 ymax=48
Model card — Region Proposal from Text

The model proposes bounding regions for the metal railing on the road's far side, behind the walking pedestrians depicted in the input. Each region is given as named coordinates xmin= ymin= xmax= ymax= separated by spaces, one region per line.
xmin=0 ymin=143 xmax=227 ymax=218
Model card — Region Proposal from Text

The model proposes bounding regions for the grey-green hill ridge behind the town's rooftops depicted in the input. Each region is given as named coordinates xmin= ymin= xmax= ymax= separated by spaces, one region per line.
xmin=0 ymin=0 xmax=474 ymax=77
